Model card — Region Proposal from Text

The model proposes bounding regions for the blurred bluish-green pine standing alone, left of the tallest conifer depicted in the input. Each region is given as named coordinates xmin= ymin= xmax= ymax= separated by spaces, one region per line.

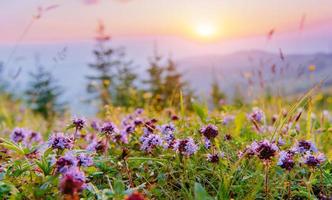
xmin=25 ymin=66 xmax=65 ymax=122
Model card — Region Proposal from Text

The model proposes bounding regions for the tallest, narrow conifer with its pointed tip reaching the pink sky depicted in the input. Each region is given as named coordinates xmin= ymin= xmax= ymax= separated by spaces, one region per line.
xmin=87 ymin=22 xmax=120 ymax=107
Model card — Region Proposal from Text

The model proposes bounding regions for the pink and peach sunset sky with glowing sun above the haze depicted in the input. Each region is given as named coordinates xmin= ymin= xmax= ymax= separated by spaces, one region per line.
xmin=0 ymin=0 xmax=332 ymax=43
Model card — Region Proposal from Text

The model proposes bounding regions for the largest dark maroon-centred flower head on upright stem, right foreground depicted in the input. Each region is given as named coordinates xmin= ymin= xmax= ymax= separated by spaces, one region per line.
xmin=251 ymin=140 xmax=278 ymax=160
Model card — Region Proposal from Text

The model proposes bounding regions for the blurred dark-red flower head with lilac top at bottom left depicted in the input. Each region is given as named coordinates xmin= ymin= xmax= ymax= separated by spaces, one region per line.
xmin=60 ymin=167 xmax=85 ymax=199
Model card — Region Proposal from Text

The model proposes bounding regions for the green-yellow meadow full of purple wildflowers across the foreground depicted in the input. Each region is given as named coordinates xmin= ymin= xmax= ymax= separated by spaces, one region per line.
xmin=0 ymin=91 xmax=332 ymax=199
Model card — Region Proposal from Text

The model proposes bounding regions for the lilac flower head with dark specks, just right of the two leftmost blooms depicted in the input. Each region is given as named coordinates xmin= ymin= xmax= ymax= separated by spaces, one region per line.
xmin=48 ymin=133 xmax=74 ymax=150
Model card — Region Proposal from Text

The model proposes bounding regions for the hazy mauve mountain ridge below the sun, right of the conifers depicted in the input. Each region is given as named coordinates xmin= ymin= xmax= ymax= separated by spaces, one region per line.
xmin=178 ymin=50 xmax=332 ymax=96
